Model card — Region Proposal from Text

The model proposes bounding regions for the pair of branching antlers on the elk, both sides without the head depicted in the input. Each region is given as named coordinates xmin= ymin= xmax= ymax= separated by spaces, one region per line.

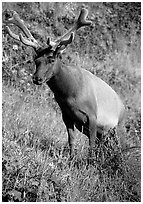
xmin=4 ymin=8 xmax=91 ymax=51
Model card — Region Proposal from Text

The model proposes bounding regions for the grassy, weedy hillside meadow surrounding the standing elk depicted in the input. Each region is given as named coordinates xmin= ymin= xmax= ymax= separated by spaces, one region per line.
xmin=2 ymin=2 xmax=141 ymax=202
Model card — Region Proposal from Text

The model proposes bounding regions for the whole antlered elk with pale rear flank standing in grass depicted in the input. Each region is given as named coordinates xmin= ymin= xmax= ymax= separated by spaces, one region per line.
xmin=5 ymin=8 xmax=124 ymax=155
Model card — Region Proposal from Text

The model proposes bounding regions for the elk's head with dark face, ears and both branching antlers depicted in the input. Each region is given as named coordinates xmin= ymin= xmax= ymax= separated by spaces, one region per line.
xmin=5 ymin=8 xmax=91 ymax=85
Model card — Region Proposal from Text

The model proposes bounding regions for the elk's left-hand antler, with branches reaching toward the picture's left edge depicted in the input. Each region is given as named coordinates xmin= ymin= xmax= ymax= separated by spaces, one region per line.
xmin=4 ymin=11 xmax=41 ymax=50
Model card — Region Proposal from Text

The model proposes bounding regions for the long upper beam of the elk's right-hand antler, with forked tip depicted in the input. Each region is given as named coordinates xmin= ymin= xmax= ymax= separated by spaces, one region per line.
xmin=56 ymin=8 xmax=92 ymax=43
